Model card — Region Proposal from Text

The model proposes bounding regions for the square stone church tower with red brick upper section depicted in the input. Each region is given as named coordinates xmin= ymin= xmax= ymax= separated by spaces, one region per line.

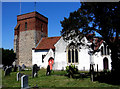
xmin=14 ymin=11 xmax=48 ymax=66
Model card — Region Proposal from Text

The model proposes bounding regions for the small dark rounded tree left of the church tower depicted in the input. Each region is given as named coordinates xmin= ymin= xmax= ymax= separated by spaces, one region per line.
xmin=2 ymin=48 xmax=16 ymax=66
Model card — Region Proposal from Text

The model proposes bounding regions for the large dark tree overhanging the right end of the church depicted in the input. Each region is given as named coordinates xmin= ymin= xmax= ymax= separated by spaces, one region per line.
xmin=61 ymin=2 xmax=120 ymax=78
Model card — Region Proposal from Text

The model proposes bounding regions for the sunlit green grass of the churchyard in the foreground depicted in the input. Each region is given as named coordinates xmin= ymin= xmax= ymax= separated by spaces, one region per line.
xmin=2 ymin=69 xmax=120 ymax=88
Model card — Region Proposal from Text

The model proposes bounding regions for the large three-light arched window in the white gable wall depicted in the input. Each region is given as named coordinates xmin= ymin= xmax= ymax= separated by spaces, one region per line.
xmin=68 ymin=44 xmax=78 ymax=63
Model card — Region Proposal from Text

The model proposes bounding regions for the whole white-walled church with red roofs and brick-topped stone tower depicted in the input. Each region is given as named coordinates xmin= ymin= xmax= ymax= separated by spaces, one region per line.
xmin=14 ymin=11 xmax=111 ymax=71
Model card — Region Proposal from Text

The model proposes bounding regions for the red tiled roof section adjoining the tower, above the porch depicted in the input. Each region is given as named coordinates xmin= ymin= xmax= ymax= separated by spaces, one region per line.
xmin=35 ymin=36 xmax=61 ymax=50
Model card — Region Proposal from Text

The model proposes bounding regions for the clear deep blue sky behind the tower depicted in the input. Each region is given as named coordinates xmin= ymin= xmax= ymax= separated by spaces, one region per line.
xmin=2 ymin=2 xmax=80 ymax=49
